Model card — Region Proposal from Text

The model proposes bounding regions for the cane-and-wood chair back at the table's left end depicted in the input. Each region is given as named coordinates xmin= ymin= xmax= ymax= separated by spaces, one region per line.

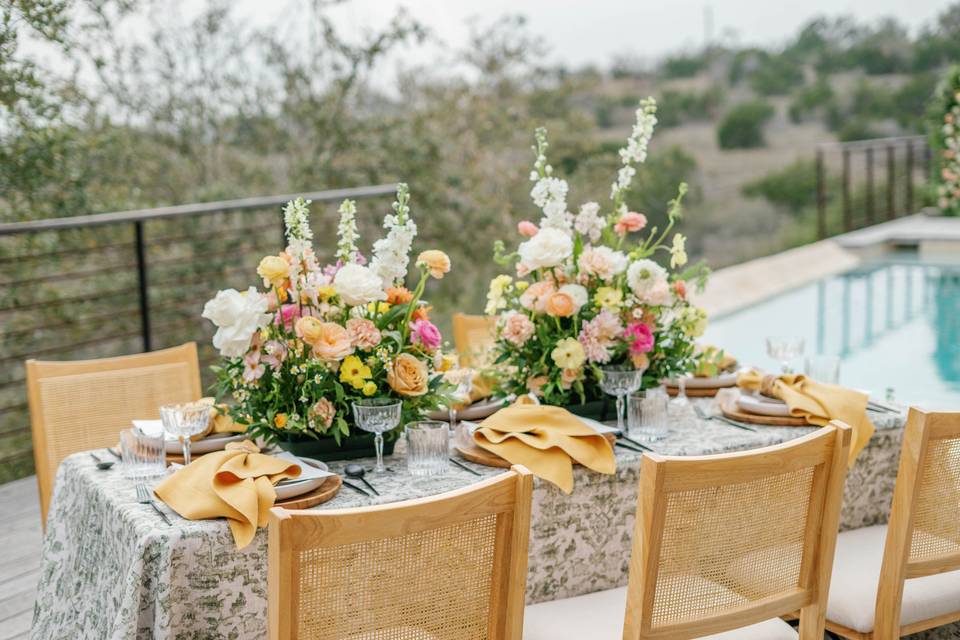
xmin=26 ymin=342 xmax=200 ymax=526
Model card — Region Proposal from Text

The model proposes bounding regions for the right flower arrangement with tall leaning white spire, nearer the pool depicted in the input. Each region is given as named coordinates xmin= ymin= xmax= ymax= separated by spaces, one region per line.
xmin=486 ymin=99 xmax=707 ymax=405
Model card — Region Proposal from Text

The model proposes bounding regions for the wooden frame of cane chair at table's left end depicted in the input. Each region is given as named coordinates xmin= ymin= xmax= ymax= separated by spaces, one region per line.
xmin=25 ymin=342 xmax=201 ymax=527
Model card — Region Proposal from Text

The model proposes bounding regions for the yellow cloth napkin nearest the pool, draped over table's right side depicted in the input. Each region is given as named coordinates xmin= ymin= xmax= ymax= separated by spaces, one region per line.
xmin=737 ymin=369 xmax=876 ymax=466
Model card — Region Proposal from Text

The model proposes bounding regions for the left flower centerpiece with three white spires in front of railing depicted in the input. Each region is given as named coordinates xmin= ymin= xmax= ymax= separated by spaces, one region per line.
xmin=203 ymin=184 xmax=450 ymax=458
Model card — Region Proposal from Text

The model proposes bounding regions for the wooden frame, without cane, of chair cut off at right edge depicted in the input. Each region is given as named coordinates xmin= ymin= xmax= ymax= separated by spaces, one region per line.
xmin=827 ymin=407 xmax=960 ymax=640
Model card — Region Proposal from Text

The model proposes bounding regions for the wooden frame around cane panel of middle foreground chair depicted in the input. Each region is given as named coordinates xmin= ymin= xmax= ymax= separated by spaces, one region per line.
xmin=623 ymin=422 xmax=851 ymax=640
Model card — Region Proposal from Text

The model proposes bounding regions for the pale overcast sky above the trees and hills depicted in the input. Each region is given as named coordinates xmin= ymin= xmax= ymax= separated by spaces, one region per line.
xmin=225 ymin=0 xmax=950 ymax=67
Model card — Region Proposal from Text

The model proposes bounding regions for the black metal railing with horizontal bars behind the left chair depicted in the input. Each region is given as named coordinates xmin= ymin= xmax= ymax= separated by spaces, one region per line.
xmin=0 ymin=184 xmax=396 ymax=482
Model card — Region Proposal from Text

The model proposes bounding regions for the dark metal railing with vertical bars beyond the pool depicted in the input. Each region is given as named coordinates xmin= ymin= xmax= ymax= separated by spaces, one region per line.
xmin=816 ymin=136 xmax=930 ymax=239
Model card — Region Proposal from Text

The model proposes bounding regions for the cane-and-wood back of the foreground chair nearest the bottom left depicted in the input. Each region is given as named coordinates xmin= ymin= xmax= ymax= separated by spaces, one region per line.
xmin=268 ymin=466 xmax=532 ymax=640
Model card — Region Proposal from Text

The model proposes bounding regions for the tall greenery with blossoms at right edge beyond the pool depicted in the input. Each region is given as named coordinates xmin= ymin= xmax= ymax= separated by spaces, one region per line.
xmin=932 ymin=65 xmax=960 ymax=216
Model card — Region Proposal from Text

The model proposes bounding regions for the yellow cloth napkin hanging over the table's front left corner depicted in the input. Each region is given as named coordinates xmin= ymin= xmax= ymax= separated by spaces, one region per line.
xmin=154 ymin=440 xmax=300 ymax=549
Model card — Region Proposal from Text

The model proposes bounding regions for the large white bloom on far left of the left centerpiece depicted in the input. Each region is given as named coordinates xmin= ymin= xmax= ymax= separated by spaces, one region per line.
xmin=202 ymin=287 xmax=270 ymax=358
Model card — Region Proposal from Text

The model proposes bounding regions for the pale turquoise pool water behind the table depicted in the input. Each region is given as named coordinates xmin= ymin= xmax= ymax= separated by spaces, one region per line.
xmin=704 ymin=253 xmax=960 ymax=410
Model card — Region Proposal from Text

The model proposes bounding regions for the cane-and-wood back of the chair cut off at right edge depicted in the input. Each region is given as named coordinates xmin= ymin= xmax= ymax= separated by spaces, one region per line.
xmin=873 ymin=408 xmax=960 ymax=638
